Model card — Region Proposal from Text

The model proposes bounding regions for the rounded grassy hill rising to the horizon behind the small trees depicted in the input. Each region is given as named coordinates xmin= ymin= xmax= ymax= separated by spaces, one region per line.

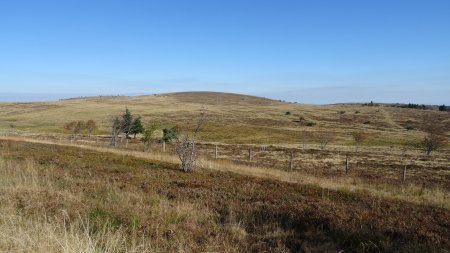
xmin=0 ymin=92 xmax=450 ymax=145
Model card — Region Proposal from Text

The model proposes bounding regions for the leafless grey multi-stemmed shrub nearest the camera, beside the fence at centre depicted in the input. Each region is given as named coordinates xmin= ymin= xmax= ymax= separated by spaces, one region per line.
xmin=175 ymin=113 xmax=206 ymax=172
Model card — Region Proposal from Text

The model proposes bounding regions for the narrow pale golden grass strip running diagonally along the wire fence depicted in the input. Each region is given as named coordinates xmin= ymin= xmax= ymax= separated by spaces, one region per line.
xmin=0 ymin=137 xmax=450 ymax=209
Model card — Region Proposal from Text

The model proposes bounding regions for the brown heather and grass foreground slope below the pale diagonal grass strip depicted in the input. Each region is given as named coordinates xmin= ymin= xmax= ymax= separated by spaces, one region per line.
xmin=0 ymin=141 xmax=450 ymax=252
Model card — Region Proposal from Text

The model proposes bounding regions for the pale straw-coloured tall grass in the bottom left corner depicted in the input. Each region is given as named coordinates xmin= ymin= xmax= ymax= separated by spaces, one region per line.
xmin=0 ymin=159 xmax=151 ymax=253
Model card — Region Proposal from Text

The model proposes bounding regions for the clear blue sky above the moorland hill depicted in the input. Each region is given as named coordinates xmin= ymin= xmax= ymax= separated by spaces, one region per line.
xmin=0 ymin=0 xmax=450 ymax=104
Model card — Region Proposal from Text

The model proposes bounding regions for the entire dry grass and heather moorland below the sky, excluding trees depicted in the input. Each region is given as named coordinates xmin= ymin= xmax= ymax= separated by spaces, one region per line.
xmin=0 ymin=92 xmax=450 ymax=252
